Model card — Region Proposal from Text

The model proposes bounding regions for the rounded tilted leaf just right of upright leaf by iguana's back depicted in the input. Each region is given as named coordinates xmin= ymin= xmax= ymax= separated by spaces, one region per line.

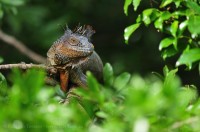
xmin=113 ymin=72 xmax=131 ymax=90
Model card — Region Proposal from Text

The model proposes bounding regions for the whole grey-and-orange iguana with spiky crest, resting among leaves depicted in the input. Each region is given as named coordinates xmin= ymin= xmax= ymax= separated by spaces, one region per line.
xmin=47 ymin=25 xmax=103 ymax=92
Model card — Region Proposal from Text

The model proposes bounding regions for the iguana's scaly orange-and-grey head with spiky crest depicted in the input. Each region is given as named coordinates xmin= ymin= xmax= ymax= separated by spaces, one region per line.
xmin=47 ymin=25 xmax=95 ymax=65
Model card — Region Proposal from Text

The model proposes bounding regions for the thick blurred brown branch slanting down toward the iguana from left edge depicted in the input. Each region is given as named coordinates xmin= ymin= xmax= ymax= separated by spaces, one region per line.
xmin=0 ymin=30 xmax=46 ymax=63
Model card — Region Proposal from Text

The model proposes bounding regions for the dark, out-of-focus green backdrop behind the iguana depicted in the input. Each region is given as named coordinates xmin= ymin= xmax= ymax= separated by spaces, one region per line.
xmin=0 ymin=0 xmax=200 ymax=87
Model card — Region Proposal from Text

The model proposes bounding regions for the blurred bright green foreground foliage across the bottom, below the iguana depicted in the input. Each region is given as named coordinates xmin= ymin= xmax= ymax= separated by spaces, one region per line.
xmin=0 ymin=63 xmax=200 ymax=132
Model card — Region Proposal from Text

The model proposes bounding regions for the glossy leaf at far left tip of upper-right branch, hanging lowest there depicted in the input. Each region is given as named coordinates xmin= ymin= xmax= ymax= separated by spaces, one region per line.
xmin=124 ymin=23 xmax=141 ymax=44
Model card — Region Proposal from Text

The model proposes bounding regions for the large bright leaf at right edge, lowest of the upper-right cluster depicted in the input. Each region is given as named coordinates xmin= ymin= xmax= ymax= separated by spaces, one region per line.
xmin=176 ymin=48 xmax=200 ymax=69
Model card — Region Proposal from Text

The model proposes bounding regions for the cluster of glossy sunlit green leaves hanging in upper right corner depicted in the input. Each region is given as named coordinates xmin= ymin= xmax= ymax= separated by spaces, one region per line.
xmin=124 ymin=0 xmax=200 ymax=72
